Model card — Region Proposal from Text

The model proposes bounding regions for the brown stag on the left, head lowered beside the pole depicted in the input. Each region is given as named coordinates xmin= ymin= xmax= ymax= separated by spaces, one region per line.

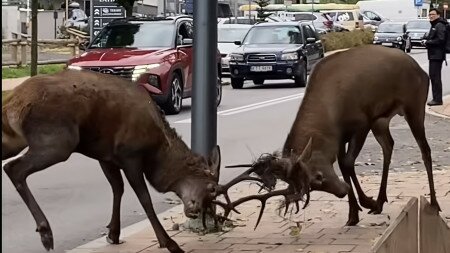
xmin=2 ymin=70 xmax=220 ymax=252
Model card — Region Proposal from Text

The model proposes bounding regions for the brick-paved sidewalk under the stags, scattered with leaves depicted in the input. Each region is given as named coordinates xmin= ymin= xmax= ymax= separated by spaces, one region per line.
xmin=67 ymin=167 xmax=450 ymax=253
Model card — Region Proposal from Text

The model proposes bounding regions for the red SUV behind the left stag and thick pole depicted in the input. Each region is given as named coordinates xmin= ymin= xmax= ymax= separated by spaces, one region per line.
xmin=67 ymin=16 xmax=222 ymax=114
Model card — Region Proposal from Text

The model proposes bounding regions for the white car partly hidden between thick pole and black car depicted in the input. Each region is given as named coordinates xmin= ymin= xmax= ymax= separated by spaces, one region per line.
xmin=217 ymin=24 xmax=252 ymax=76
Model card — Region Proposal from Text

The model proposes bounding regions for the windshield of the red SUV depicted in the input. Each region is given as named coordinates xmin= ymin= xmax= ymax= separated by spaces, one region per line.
xmin=90 ymin=23 xmax=174 ymax=48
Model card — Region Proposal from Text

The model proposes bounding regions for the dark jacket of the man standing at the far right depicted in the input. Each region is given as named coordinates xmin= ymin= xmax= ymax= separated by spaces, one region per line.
xmin=425 ymin=18 xmax=447 ymax=60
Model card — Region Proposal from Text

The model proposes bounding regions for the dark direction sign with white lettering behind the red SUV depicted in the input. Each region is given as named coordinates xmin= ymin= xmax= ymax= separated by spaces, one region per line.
xmin=90 ymin=0 xmax=126 ymax=40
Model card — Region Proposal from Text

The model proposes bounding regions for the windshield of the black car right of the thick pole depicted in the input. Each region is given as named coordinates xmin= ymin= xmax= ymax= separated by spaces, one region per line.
xmin=243 ymin=26 xmax=303 ymax=45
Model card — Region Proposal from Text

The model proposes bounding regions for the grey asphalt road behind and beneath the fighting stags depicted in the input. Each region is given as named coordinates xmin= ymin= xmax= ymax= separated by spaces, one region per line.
xmin=2 ymin=49 xmax=450 ymax=253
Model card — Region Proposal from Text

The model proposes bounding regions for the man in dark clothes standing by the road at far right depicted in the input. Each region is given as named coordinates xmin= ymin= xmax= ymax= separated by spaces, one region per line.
xmin=422 ymin=9 xmax=447 ymax=106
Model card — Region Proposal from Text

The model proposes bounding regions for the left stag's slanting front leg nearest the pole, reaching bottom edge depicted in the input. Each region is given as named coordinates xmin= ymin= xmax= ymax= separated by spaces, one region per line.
xmin=124 ymin=163 xmax=184 ymax=253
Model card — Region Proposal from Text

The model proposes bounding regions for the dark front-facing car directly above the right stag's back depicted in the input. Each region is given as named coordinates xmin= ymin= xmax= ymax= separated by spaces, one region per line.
xmin=373 ymin=22 xmax=412 ymax=53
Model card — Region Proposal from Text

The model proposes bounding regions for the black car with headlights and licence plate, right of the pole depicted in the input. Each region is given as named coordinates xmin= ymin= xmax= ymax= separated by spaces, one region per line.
xmin=230 ymin=22 xmax=324 ymax=89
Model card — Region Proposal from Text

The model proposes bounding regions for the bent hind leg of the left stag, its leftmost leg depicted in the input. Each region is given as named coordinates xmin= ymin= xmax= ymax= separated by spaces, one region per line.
xmin=4 ymin=146 xmax=71 ymax=250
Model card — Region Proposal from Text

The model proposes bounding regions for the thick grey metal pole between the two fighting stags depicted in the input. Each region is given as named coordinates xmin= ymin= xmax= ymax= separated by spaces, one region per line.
xmin=191 ymin=0 xmax=218 ymax=156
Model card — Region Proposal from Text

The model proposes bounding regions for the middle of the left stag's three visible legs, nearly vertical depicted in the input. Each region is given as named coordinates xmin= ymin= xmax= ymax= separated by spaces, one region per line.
xmin=100 ymin=162 xmax=123 ymax=244
